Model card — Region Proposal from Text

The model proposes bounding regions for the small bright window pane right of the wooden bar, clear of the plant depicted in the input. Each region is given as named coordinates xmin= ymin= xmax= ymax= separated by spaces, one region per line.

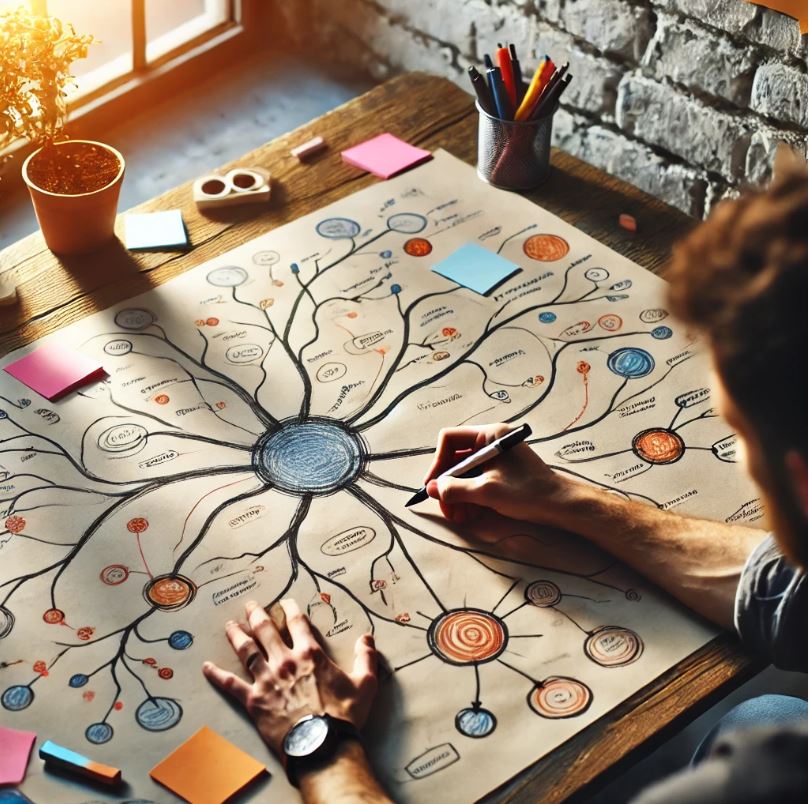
xmin=146 ymin=0 xmax=230 ymax=61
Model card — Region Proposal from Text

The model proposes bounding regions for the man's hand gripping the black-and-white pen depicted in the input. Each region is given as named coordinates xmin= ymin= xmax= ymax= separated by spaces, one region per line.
xmin=424 ymin=424 xmax=584 ymax=527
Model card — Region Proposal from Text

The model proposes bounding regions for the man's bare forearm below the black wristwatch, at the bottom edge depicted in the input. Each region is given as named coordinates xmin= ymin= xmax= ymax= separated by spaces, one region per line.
xmin=300 ymin=740 xmax=391 ymax=804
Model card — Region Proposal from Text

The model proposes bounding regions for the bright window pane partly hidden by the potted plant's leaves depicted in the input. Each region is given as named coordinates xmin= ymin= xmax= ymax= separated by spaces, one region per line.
xmin=48 ymin=0 xmax=132 ymax=92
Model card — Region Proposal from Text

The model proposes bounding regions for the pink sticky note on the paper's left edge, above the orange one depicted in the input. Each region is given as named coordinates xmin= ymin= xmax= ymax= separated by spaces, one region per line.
xmin=4 ymin=343 xmax=104 ymax=400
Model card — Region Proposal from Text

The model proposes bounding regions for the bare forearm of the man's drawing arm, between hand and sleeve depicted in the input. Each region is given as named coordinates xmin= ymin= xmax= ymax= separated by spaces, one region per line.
xmin=538 ymin=483 xmax=764 ymax=629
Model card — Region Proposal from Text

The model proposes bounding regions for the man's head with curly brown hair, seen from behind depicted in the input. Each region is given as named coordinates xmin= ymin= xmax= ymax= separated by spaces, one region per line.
xmin=668 ymin=160 xmax=807 ymax=567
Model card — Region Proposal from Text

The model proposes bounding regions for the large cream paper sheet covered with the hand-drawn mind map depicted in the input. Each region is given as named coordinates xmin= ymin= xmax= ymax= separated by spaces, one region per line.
xmin=0 ymin=152 xmax=761 ymax=803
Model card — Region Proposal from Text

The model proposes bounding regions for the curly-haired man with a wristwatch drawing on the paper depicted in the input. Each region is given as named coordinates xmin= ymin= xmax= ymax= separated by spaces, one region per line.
xmin=204 ymin=163 xmax=807 ymax=804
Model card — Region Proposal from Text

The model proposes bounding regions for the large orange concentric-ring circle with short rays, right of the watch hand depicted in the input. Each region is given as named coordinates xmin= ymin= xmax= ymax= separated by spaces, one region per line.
xmin=427 ymin=609 xmax=508 ymax=665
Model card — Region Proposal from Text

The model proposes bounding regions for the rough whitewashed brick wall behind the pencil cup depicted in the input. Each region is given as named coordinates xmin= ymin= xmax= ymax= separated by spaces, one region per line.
xmin=276 ymin=0 xmax=807 ymax=217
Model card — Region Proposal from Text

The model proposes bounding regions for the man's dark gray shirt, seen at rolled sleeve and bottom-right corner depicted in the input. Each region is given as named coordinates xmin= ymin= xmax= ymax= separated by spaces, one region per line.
xmin=633 ymin=536 xmax=807 ymax=804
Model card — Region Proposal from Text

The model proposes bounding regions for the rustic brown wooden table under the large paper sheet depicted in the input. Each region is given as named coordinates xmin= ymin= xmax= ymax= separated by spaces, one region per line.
xmin=0 ymin=73 xmax=762 ymax=802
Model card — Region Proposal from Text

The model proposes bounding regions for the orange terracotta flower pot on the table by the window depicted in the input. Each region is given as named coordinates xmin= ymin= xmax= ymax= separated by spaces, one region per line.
xmin=22 ymin=140 xmax=124 ymax=254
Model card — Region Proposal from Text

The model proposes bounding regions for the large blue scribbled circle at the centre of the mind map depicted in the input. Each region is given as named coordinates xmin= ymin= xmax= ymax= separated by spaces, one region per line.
xmin=253 ymin=418 xmax=364 ymax=494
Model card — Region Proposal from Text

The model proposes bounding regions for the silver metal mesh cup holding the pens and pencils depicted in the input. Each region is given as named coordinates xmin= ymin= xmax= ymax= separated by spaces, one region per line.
xmin=475 ymin=101 xmax=556 ymax=190
